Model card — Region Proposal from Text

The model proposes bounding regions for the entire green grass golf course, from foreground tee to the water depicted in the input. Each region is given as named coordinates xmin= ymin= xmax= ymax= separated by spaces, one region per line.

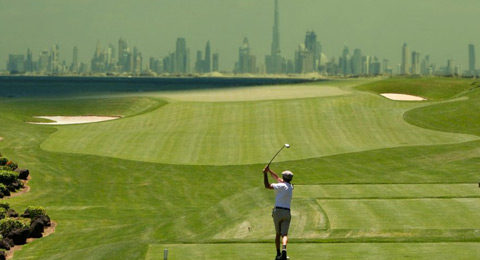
xmin=0 ymin=78 xmax=480 ymax=260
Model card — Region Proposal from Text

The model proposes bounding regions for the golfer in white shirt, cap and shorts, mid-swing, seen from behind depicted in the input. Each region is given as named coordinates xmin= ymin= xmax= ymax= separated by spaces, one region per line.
xmin=263 ymin=166 xmax=293 ymax=260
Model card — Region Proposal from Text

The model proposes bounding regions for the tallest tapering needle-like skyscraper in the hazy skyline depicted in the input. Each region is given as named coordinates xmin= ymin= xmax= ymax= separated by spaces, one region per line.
xmin=265 ymin=0 xmax=283 ymax=74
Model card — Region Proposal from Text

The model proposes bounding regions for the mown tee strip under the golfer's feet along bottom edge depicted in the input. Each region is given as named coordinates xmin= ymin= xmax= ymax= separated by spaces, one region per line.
xmin=145 ymin=243 xmax=480 ymax=260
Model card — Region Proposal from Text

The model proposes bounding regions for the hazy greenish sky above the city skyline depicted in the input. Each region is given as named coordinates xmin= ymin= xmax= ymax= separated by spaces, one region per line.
xmin=0 ymin=0 xmax=480 ymax=71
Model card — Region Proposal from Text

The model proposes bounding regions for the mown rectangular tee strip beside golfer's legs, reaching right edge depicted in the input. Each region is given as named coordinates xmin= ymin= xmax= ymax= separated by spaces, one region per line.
xmin=319 ymin=198 xmax=480 ymax=230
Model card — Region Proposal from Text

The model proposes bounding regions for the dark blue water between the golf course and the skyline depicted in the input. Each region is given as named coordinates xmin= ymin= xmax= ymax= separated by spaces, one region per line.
xmin=0 ymin=76 xmax=312 ymax=98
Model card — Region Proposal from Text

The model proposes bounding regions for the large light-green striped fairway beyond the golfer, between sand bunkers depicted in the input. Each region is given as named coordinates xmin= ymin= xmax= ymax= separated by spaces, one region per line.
xmin=42 ymin=94 xmax=478 ymax=165
